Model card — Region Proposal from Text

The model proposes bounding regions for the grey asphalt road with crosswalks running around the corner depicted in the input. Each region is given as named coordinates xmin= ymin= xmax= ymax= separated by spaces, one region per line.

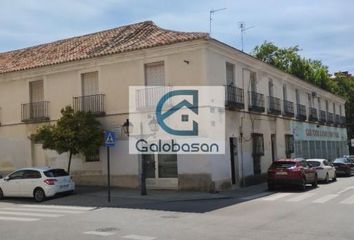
xmin=0 ymin=177 xmax=354 ymax=240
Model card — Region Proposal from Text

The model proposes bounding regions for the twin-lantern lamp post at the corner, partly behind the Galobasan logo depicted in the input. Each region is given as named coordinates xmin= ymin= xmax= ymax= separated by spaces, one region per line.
xmin=122 ymin=117 xmax=158 ymax=196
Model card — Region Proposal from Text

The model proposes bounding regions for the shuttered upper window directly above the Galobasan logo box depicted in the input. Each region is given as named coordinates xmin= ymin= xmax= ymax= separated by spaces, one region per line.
xmin=145 ymin=62 xmax=165 ymax=86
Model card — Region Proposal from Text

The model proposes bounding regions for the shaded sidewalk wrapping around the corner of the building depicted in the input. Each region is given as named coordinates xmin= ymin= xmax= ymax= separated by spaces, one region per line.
xmin=3 ymin=184 xmax=272 ymax=213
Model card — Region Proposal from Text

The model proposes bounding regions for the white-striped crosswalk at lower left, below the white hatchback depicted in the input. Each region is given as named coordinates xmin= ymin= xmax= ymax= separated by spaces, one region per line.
xmin=0 ymin=204 xmax=94 ymax=222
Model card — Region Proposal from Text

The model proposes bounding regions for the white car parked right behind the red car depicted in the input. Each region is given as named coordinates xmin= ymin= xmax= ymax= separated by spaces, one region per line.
xmin=306 ymin=158 xmax=337 ymax=183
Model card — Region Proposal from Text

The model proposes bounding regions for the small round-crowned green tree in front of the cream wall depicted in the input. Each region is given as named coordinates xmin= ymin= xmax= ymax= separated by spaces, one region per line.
xmin=32 ymin=106 xmax=103 ymax=173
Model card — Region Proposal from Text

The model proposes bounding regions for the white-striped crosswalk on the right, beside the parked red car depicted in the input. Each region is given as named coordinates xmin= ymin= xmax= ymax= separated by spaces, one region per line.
xmin=254 ymin=192 xmax=354 ymax=205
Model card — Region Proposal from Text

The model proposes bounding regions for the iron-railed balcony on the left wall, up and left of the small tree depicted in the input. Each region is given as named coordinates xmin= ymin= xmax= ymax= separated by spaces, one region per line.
xmin=21 ymin=101 xmax=49 ymax=122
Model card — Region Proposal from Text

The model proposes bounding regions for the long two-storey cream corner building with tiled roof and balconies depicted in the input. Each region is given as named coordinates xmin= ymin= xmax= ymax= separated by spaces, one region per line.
xmin=0 ymin=22 xmax=348 ymax=191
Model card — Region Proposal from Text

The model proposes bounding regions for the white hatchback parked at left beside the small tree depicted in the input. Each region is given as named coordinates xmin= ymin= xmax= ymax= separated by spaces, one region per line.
xmin=0 ymin=168 xmax=75 ymax=202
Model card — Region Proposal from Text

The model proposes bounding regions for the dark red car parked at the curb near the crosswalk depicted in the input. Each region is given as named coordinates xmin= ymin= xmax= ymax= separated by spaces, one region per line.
xmin=267 ymin=159 xmax=317 ymax=190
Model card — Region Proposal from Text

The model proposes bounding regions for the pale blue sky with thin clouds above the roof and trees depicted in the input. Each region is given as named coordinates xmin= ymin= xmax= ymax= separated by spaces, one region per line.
xmin=0 ymin=0 xmax=354 ymax=73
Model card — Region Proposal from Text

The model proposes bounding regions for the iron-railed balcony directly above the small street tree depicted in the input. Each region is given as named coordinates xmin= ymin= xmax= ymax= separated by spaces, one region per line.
xmin=73 ymin=94 xmax=105 ymax=116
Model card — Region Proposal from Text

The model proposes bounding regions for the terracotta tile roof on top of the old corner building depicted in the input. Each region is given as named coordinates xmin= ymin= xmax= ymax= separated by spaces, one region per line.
xmin=0 ymin=21 xmax=209 ymax=73
